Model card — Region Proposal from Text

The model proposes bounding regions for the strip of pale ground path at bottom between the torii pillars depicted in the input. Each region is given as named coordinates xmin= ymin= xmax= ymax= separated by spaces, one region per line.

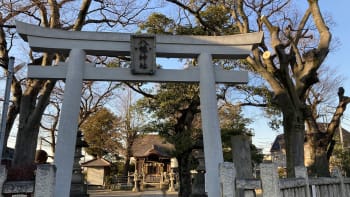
xmin=89 ymin=190 xmax=178 ymax=197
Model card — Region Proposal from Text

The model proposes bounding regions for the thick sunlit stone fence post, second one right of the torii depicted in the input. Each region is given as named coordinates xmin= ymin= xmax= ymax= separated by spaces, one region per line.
xmin=260 ymin=163 xmax=281 ymax=197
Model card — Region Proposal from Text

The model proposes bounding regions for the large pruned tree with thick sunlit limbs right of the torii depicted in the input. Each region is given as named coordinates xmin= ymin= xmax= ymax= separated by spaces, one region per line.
xmin=243 ymin=1 xmax=331 ymax=177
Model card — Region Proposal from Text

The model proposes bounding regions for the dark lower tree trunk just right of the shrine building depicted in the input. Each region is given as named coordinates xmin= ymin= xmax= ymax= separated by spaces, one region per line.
xmin=177 ymin=152 xmax=192 ymax=197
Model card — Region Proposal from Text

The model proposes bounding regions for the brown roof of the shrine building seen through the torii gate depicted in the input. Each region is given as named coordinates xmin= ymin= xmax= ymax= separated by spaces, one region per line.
xmin=131 ymin=135 xmax=175 ymax=157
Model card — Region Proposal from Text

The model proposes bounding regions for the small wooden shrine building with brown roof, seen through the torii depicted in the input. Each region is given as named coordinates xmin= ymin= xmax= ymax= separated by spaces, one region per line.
xmin=132 ymin=135 xmax=175 ymax=188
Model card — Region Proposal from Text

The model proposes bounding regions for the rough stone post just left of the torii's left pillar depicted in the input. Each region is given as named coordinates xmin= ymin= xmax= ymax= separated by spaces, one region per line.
xmin=34 ymin=164 xmax=56 ymax=197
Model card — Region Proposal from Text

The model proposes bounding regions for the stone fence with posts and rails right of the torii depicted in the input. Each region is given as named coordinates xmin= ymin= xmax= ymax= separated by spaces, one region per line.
xmin=220 ymin=162 xmax=350 ymax=197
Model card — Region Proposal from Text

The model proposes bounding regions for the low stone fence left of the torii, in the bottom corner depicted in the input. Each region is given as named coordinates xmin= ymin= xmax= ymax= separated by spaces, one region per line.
xmin=0 ymin=164 xmax=56 ymax=197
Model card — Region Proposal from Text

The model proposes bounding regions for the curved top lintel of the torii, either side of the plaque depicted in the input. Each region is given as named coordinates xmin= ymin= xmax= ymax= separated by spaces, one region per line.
xmin=16 ymin=21 xmax=263 ymax=59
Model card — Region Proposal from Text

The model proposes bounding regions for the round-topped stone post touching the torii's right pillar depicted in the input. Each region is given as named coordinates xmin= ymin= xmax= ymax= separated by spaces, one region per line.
xmin=219 ymin=162 xmax=237 ymax=197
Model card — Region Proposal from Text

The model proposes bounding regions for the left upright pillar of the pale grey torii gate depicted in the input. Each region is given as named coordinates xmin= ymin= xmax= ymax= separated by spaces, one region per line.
xmin=54 ymin=49 xmax=86 ymax=197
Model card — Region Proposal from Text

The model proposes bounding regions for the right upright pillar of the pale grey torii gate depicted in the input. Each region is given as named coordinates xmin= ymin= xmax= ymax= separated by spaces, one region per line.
xmin=198 ymin=53 xmax=224 ymax=197
